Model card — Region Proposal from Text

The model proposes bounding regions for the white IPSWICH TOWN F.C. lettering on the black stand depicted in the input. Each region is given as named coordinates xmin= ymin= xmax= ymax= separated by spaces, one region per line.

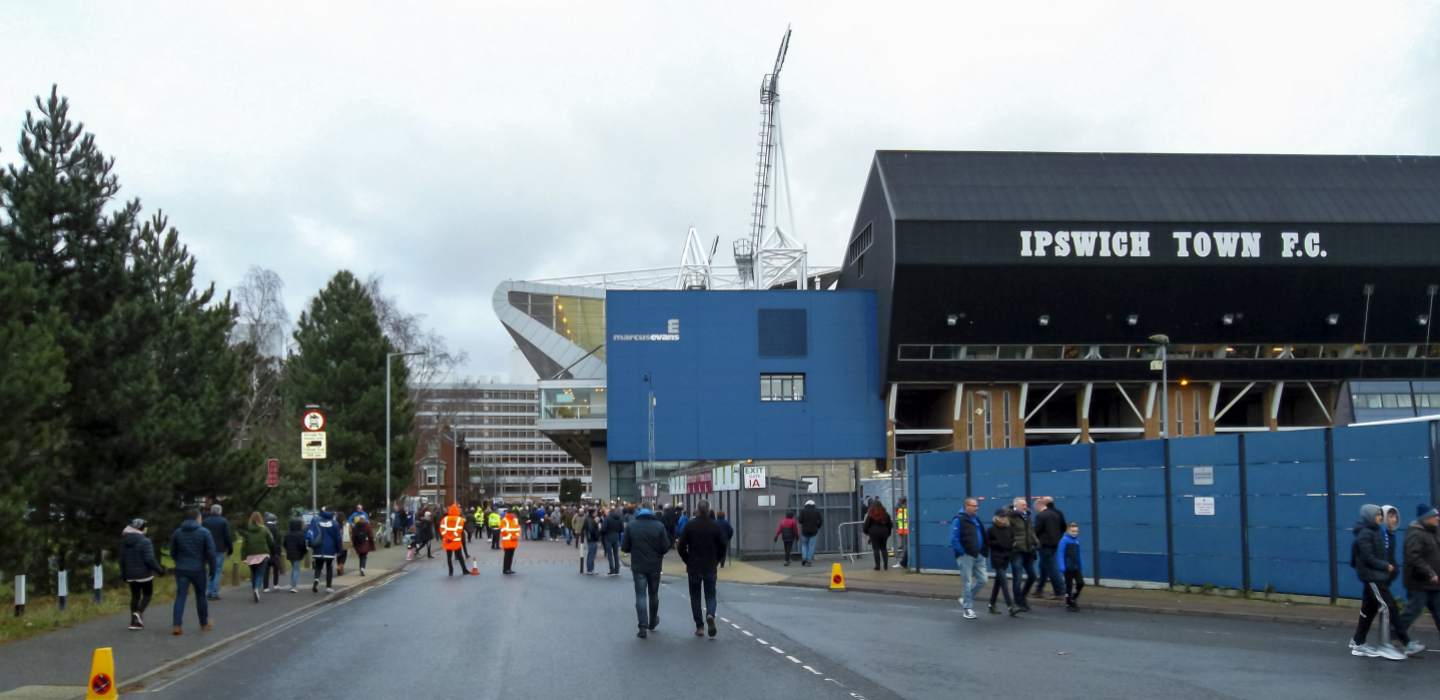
xmin=1020 ymin=230 xmax=1329 ymax=259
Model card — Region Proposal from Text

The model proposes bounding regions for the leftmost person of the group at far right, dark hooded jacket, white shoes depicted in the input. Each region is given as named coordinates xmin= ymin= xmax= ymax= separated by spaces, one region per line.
xmin=1349 ymin=503 xmax=1410 ymax=661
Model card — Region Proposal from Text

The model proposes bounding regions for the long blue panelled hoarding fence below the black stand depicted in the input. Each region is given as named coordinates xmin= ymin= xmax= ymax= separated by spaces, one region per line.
xmin=906 ymin=421 xmax=1440 ymax=601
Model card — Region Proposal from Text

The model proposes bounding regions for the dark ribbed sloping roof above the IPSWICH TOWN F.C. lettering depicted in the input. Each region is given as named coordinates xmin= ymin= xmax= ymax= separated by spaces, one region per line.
xmin=876 ymin=151 xmax=1440 ymax=223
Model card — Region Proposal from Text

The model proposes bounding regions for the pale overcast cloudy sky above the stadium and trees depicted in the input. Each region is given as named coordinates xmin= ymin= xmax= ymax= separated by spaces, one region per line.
xmin=0 ymin=0 xmax=1440 ymax=374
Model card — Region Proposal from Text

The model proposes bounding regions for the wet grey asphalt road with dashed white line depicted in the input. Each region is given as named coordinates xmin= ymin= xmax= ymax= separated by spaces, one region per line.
xmin=135 ymin=543 xmax=1440 ymax=700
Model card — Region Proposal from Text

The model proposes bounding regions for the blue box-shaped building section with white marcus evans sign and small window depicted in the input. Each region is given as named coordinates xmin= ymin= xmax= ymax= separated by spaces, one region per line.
xmin=605 ymin=290 xmax=886 ymax=462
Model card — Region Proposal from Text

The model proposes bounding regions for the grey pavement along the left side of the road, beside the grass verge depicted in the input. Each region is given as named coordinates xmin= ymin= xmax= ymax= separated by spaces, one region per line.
xmin=0 ymin=532 xmax=411 ymax=700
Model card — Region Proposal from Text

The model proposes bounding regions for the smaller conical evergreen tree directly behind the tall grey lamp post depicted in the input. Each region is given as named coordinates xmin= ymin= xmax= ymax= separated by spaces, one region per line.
xmin=282 ymin=271 xmax=415 ymax=513
